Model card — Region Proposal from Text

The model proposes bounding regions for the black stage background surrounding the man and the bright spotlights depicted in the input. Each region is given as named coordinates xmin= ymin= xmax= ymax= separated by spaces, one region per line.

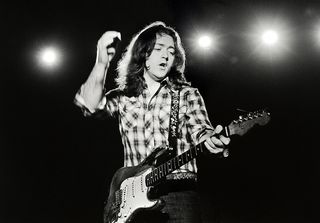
xmin=0 ymin=0 xmax=320 ymax=223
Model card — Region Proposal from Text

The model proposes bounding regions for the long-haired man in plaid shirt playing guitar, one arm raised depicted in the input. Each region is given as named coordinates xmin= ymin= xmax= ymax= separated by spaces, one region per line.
xmin=75 ymin=22 xmax=230 ymax=223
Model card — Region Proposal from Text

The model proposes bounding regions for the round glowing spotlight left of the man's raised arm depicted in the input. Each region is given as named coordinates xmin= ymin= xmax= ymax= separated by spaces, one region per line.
xmin=37 ymin=46 xmax=62 ymax=69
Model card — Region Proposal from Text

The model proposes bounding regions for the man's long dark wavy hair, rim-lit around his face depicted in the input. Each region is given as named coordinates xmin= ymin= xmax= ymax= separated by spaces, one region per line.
xmin=116 ymin=22 xmax=188 ymax=96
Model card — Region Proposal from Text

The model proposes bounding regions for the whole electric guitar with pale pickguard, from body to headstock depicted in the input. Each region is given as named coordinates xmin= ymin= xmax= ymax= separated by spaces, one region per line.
xmin=104 ymin=110 xmax=270 ymax=223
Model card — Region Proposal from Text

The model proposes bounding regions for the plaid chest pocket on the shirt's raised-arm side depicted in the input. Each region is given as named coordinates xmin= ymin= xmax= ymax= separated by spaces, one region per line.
xmin=119 ymin=98 xmax=141 ymax=131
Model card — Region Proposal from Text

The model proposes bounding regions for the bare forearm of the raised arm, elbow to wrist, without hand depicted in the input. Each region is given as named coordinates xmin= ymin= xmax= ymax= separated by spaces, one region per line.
xmin=79 ymin=63 xmax=108 ymax=111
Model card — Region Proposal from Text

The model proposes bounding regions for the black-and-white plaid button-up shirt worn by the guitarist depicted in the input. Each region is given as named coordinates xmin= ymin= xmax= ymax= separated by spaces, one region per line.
xmin=75 ymin=82 xmax=213 ymax=172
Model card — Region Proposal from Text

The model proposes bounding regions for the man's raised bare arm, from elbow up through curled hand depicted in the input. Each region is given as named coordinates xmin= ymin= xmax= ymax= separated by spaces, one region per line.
xmin=76 ymin=31 xmax=121 ymax=112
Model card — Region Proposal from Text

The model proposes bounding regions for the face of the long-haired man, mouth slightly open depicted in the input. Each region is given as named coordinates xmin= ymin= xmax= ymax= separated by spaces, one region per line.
xmin=146 ymin=34 xmax=175 ymax=82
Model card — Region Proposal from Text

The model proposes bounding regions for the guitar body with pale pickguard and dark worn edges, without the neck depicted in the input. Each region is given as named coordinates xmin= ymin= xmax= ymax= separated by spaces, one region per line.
xmin=104 ymin=149 xmax=170 ymax=223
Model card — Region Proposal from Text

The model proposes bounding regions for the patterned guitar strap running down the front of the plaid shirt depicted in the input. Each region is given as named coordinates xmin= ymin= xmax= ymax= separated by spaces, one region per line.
xmin=168 ymin=89 xmax=180 ymax=155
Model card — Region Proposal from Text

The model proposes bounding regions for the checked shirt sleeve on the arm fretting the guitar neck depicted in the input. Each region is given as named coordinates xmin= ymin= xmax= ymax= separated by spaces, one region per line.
xmin=187 ymin=89 xmax=213 ymax=144
